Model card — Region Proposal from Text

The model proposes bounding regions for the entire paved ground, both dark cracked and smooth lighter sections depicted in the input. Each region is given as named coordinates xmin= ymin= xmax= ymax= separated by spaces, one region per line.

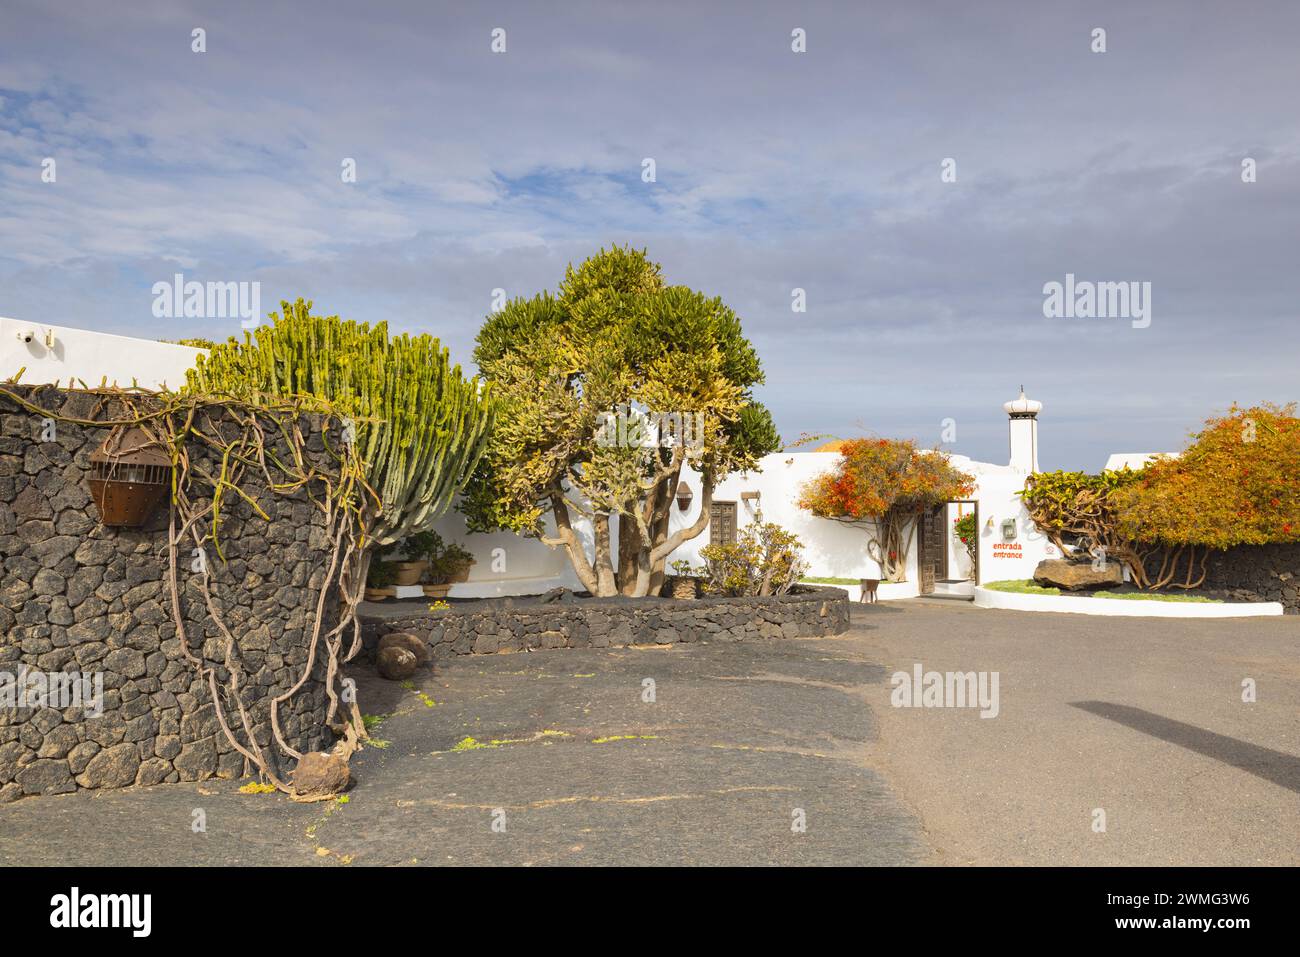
xmin=0 ymin=601 xmax=1300 ymax=866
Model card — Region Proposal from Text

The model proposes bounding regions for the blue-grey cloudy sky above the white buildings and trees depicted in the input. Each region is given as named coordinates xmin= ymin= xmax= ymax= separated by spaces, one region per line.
xmin=0 ymin=0 xmax=1300 ymax=471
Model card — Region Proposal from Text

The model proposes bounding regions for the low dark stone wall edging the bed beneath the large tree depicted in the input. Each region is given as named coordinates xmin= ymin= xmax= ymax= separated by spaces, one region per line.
xmin=361 ymin=588 xmax=849 ymax=658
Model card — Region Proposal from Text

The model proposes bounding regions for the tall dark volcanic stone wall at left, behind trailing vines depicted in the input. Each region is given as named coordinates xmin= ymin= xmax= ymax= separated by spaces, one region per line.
xmin=0 ymin=386 xmax=338 ymax=802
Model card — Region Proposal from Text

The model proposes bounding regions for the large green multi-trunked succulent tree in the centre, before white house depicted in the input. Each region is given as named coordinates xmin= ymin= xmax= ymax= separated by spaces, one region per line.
xmin=462 ymin=246 xmax=780 ymax=596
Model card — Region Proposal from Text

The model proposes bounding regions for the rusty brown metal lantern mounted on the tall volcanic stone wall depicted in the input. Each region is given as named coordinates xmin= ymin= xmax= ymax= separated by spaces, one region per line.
xmin=86 ymin=428 xmax=172 ymax=528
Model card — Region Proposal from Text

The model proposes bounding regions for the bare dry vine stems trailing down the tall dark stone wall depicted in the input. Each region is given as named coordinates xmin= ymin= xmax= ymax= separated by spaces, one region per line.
xmin=0 ymin=387 xmax=378 ymax=796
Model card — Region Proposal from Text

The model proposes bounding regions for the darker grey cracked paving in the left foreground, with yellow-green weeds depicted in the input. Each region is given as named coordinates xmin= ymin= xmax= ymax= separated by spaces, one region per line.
xmin=0 ymin=613 xmax=927 ymax=865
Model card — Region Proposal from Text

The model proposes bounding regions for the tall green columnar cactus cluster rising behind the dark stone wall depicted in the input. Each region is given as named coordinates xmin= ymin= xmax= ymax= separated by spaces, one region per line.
xmin=186 ymin=299 xmax=493 ymax=545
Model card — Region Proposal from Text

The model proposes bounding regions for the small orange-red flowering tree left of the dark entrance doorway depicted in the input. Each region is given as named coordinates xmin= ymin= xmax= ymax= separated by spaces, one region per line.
xmin=800 ymin=438 xmax=975 ymax=581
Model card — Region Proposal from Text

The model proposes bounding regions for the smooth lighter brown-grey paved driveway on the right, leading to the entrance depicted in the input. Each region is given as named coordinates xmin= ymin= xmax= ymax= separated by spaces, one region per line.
xmin=852 ymin=601 xmax=1300 ymax=865
